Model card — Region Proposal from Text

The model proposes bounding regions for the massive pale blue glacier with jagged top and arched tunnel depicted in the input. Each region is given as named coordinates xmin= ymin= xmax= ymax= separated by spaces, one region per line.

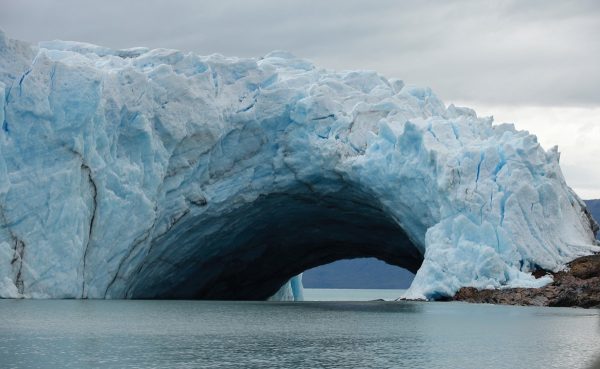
xmin=0 ymin=32 xmax=599 ymax=300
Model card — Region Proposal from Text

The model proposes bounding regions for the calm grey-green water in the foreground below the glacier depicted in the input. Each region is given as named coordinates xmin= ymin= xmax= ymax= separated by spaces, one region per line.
xmin=0 ymin=291 xmax=600 ymax=369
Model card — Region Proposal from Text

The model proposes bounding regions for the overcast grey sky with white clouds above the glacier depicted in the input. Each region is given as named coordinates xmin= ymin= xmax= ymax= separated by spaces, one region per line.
xmin=0 ymin=0 xmax=600 ymax=199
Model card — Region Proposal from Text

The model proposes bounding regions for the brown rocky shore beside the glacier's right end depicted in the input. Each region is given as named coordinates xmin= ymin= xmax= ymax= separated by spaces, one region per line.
xmin=453 ymin=254 xmax=600 ymax=308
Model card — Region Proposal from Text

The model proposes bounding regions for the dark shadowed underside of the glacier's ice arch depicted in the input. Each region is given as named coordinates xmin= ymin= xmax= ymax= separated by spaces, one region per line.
xmin=127 ymin=186 xmax=423 ymax=300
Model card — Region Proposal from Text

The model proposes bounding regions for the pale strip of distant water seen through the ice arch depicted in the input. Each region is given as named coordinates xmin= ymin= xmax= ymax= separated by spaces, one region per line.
xmin=304 ymin=288 xmax=405 ymax=301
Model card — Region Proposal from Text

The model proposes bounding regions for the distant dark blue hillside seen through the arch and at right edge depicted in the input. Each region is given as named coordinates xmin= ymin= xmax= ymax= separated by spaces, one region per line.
xmin=302 ymin=199 xmax=600 ymax=289
